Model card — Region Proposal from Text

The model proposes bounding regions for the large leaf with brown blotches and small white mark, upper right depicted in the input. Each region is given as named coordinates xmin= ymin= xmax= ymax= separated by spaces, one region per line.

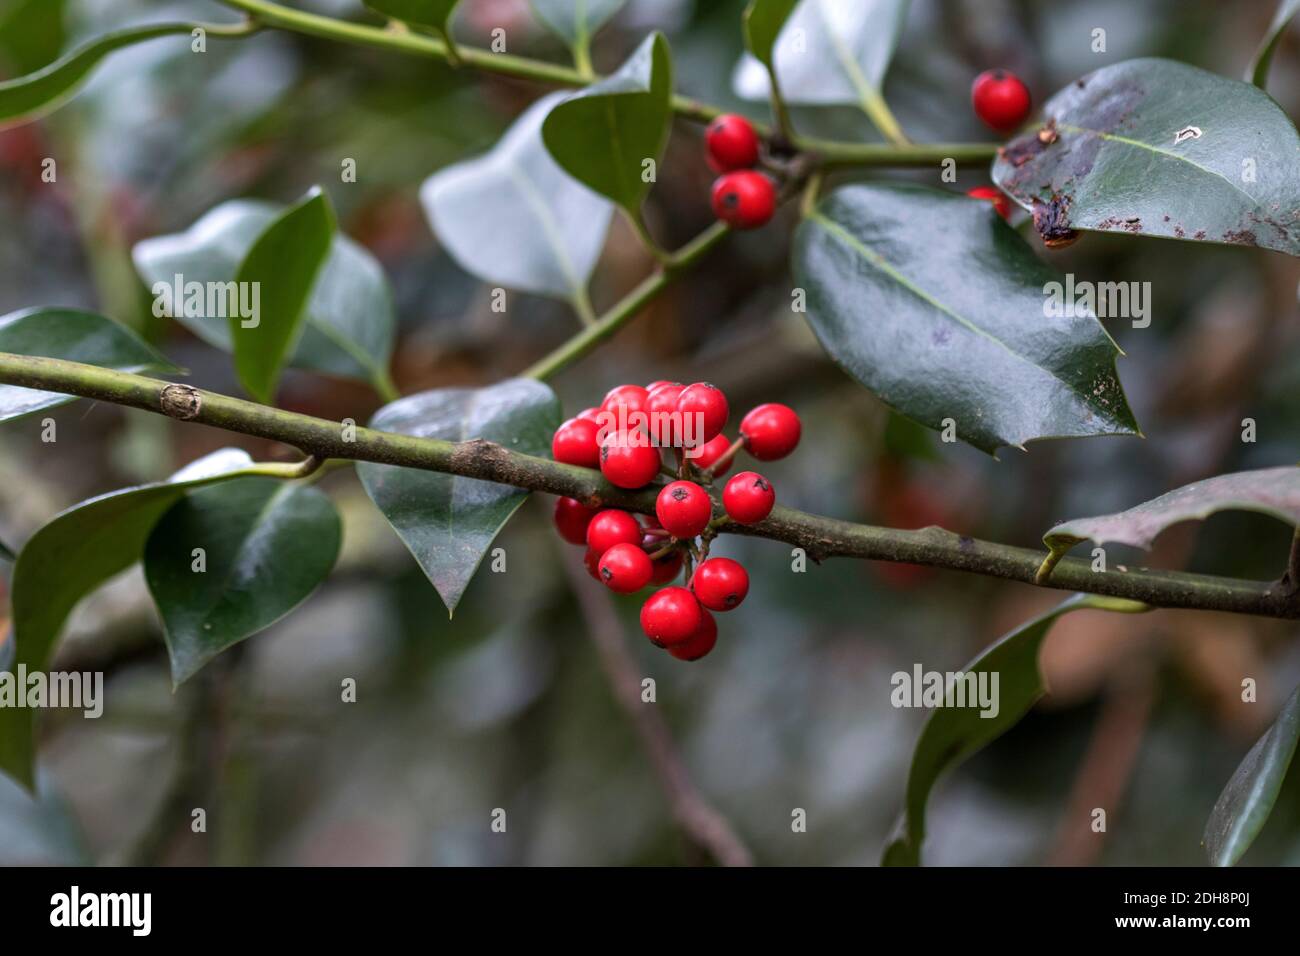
xmin=993 ymin=59 xmax=1300 ymax=255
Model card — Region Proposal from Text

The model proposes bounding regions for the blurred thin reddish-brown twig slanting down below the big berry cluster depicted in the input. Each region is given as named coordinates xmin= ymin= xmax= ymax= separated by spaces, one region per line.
xmin=560 ymin=538 xmax=754 ymax=866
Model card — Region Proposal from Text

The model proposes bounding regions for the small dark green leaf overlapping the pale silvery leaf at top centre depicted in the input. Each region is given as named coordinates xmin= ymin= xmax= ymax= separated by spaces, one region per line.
xmin=542 ymin=31 xmax=672 ymax=216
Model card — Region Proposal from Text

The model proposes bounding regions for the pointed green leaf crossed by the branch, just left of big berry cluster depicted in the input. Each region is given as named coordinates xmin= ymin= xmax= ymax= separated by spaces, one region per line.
xmin=356 ymin=378 xmax=560 ymax=611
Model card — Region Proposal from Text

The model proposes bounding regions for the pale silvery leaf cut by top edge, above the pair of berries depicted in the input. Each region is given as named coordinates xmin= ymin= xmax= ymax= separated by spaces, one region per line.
xmin=735 ymin=0 xmax=907 ymax=112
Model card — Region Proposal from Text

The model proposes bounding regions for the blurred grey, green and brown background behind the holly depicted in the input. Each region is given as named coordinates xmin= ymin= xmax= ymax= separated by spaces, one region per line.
xmin=0 ymin=0 xmax=1300 ymax=865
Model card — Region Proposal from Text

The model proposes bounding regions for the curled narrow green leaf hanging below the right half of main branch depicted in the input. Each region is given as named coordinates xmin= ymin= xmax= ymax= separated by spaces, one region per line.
xmin=880 ymin=594 xmax=1149 ymax=866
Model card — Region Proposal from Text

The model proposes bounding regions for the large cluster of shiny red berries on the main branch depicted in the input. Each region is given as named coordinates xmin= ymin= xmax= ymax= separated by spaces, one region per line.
xmin=551 ymin=381 xmax=802 ymax=661
